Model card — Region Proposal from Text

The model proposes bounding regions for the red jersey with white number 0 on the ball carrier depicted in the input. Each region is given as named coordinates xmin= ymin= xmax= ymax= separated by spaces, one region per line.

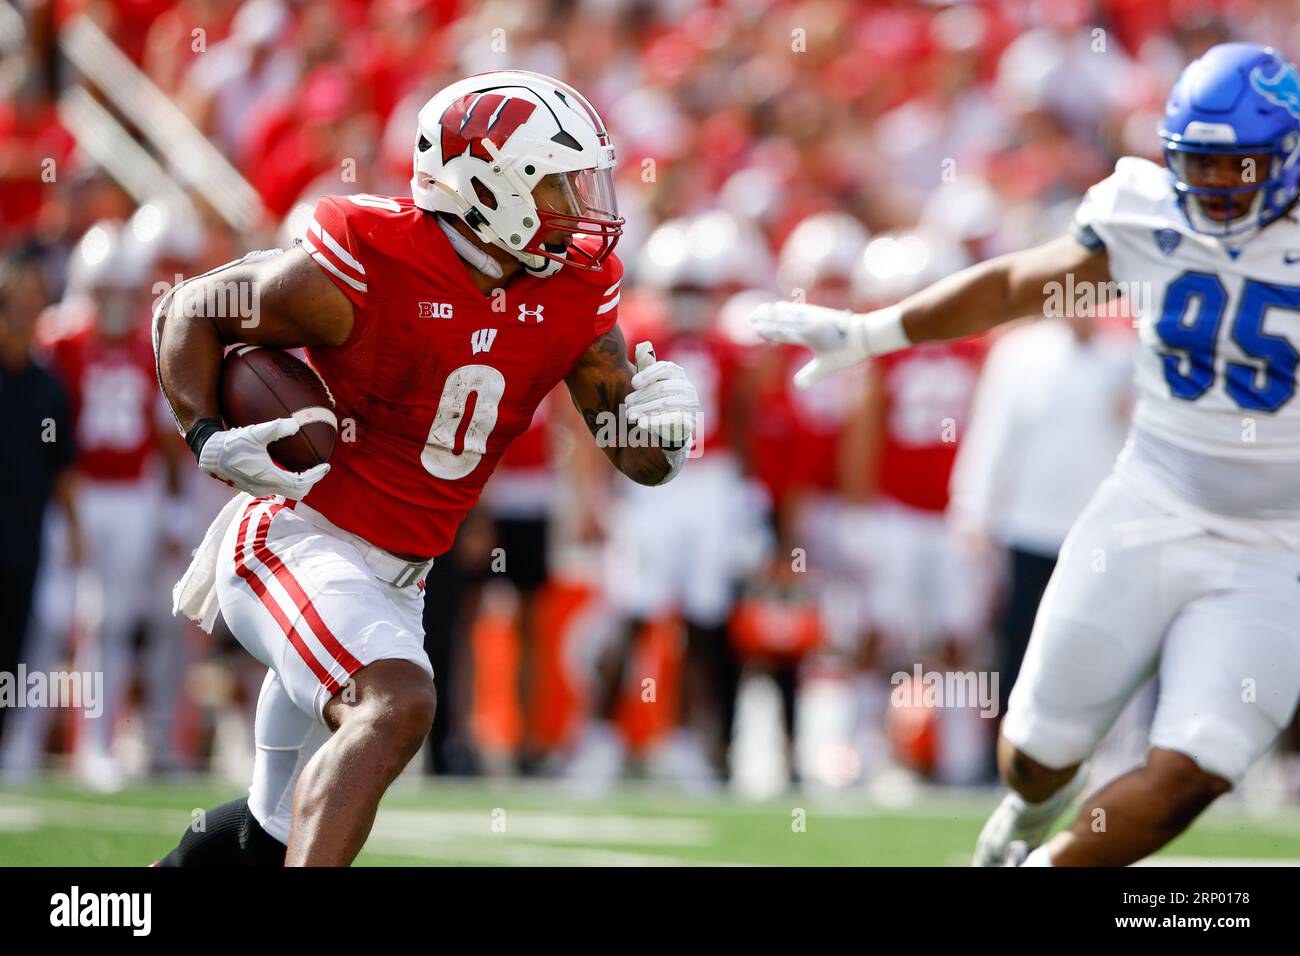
xmin=303 ymin=194 xmax=623 ymax=555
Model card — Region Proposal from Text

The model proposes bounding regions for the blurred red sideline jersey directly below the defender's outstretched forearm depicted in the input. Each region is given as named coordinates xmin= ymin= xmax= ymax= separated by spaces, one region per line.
xmin=872 ymin=338 xmax=988 ymax=511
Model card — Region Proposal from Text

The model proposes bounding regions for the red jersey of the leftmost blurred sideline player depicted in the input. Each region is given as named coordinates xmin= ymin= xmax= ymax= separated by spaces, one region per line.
xmin=52 ymin=325 xmax=159 ymax=481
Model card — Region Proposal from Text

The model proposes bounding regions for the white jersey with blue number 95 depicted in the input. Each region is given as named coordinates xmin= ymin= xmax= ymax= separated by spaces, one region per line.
xmin=1075 ymin=157 xmax=1300 ymax=462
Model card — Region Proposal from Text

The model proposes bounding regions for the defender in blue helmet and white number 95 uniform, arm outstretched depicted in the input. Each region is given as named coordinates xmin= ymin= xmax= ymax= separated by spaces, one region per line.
xmin=755 ymin=43 xmax=1300 ymax=866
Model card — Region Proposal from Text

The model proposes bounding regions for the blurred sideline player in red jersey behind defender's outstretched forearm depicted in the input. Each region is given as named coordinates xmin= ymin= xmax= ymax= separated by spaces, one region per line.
xmin=814 ymin=230 xmax=993 ymax=784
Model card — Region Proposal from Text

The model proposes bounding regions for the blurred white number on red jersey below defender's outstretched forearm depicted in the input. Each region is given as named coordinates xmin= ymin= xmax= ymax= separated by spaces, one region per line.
xmin=885 ymin=354 xmax=976 ymax=447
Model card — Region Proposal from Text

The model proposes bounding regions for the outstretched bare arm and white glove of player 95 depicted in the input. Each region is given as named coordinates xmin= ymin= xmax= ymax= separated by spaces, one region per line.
xmin=754 ymin=235 xmax=1110 ymax=388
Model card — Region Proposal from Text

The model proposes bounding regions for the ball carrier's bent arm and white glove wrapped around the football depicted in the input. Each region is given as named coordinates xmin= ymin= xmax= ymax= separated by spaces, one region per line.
xmin=153 ymin=248 xmax=354 ymax=498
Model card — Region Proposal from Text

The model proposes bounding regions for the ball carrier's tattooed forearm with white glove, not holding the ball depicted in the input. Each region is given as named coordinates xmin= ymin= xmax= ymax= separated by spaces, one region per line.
xmin=564 ymin=325 xmax=698 ymax=485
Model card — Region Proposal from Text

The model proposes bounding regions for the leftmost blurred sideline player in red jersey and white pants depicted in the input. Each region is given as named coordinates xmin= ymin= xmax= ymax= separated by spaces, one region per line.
xmin=22 ymin=221 xmax=181 ymax=790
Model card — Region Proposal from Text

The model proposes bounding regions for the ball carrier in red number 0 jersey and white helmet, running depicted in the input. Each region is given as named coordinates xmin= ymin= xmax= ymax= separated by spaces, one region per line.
xmin=155 ymin=72 xmax=698 ymax=865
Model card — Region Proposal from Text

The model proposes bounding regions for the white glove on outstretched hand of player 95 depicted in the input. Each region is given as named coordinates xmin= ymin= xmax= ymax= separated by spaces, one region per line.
xmin=750 ymin=302 xmax=910 ymax=389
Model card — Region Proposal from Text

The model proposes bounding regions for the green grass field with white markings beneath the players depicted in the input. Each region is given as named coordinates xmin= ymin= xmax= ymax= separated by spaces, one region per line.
xmin=0 ymin=780 xmax=1300 ymax=866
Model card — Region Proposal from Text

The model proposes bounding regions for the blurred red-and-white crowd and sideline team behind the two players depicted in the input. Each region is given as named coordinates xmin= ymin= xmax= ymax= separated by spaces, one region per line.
xmin=0 ymin=0 xmax=1300 ymax=795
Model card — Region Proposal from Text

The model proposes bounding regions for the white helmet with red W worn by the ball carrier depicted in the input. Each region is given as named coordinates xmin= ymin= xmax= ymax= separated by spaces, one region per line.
xmin=411 ymin=70 xmax=623 ymax=276
